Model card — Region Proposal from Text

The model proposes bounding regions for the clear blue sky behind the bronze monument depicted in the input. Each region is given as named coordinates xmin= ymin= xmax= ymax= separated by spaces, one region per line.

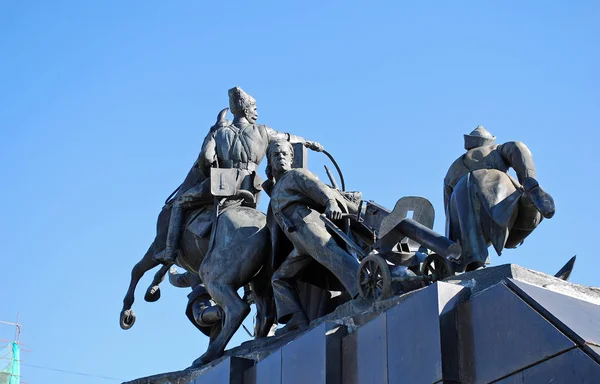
xmin=0 ymin=0 xmax=600 ymax=384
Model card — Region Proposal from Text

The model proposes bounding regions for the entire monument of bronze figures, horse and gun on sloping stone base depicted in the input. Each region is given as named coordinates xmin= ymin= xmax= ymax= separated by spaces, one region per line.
xmin=120 ymin=87 xmax=600 ymax=384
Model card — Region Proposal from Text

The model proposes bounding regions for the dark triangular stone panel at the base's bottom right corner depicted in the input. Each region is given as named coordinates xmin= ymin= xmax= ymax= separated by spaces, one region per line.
xmin=496 ymin=348 xmax=600 ymax=384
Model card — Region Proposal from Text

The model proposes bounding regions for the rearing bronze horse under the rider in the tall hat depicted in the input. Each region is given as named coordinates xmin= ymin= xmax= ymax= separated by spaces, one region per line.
xmin=120 ymin=192 xmax=275 ymax=366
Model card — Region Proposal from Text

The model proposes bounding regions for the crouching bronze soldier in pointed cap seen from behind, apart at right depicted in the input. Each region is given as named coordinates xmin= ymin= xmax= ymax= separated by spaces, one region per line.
xmin=444 ymin=126 xmax=555 ymax=272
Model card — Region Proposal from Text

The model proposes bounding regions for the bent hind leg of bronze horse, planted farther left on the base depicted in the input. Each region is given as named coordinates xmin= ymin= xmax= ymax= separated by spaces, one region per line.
xmin=192 ymin=279 xmax=250 ymax=367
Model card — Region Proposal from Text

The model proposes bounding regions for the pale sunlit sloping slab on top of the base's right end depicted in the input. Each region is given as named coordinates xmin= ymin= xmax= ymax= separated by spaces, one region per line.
xmin=508 ymin=279 xmax=600 ymax=345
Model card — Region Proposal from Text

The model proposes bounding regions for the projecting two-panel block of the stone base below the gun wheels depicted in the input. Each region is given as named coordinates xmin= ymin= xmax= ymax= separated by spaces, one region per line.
xmin=343 ymin=282 xmax=468 ymax=383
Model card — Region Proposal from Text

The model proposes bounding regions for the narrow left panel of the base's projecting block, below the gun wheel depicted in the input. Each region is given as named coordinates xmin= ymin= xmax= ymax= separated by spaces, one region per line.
xmin=342 ymin=315 xmax=388 ymax=384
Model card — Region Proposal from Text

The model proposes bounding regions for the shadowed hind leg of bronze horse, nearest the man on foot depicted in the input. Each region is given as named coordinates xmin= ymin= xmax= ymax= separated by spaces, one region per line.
xmin=250 ymin=265 xmax=275 ymax=339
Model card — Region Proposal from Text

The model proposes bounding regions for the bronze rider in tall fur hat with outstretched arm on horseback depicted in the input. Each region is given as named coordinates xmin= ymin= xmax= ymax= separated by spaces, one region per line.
xmin=155 ymin=87 xmax=323 ymax=264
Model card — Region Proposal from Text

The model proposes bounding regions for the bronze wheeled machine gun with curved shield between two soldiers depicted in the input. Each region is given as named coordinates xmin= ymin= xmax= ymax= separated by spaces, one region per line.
xmin=323 ymin=196 xmax=461 ymax=301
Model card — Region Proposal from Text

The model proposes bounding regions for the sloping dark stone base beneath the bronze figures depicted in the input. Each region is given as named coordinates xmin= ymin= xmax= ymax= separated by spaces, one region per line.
xmin=122 ymin=265 xmax=600 ymax=384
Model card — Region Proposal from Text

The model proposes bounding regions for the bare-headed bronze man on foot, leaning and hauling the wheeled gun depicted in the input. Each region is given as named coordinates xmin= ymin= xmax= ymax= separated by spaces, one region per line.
xmin=267 ymin=141 xmax=359 ymax=331
